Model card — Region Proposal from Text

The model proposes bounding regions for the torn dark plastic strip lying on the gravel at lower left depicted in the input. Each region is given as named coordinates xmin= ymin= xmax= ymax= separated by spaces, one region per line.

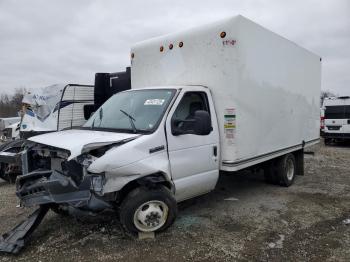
xmin=0 ymin=205 xmax=49 ymax=254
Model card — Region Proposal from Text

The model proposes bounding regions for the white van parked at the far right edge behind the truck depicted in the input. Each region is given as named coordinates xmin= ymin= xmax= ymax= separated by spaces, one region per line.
xmin=322 ymin=96 xmax=350 ymax=144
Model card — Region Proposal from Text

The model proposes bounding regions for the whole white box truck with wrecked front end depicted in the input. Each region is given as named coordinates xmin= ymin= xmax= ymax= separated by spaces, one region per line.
xmin=16 ymin=16 xmax=321 ymax=236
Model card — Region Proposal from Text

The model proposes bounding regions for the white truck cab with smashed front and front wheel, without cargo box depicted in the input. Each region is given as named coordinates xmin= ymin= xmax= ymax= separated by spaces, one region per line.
xmin=17 ymin=86 xmax=220 ymax=231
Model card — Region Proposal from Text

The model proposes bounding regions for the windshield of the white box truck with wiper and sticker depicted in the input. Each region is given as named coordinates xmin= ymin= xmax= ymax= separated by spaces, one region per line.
xmin=83 ymin=89 xmax=175 ymax=133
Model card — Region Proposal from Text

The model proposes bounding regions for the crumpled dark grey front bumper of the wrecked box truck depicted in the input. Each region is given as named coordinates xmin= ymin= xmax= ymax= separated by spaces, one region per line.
xmin=16 ymin=170 xmax=104 ymax=208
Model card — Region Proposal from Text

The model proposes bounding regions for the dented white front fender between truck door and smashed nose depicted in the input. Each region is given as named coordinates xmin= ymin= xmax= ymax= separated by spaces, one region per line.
xmin=87 ymin=129 xmax=171 ymax=193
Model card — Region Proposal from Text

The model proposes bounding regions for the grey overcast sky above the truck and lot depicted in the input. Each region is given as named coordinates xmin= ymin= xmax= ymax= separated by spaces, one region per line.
xmin=0 ymin=0 xmax=350 ymax=95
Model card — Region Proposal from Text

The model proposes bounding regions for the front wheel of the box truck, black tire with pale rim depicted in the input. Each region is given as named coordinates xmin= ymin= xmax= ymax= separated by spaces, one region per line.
xmin=120 ymin=186 xmax=177 ymax=233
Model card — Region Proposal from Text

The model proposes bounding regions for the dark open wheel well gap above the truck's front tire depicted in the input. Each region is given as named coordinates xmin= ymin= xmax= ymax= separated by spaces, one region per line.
xmin=116 ymin=173 xmax=173 ymax=203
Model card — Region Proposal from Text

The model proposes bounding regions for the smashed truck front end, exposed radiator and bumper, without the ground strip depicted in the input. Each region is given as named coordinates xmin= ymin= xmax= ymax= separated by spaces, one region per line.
xmin=16 ymin=143 xmax=112 ymax=212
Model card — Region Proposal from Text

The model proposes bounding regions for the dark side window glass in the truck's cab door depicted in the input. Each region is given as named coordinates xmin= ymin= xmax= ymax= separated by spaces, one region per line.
xmin=171 ymin=92 xmax=210 ymax=134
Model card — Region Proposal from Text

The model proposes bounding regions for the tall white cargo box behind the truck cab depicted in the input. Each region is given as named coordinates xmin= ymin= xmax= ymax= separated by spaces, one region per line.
xmin=131 ymin=16 xmax=321 ymax=171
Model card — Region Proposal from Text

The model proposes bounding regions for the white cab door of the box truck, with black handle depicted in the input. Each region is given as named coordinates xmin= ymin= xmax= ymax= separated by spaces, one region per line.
xmin=166 ymin=87 xmax=220 ymax=201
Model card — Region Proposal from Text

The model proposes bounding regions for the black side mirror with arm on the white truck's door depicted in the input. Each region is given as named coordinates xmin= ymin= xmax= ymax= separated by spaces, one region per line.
xmin=171 ymin=110 xmax=213 ymax=136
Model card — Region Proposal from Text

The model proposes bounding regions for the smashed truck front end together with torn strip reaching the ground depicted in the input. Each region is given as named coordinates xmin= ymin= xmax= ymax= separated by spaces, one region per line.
xmin=0 ymin=142 xmax=124 ymax=254
